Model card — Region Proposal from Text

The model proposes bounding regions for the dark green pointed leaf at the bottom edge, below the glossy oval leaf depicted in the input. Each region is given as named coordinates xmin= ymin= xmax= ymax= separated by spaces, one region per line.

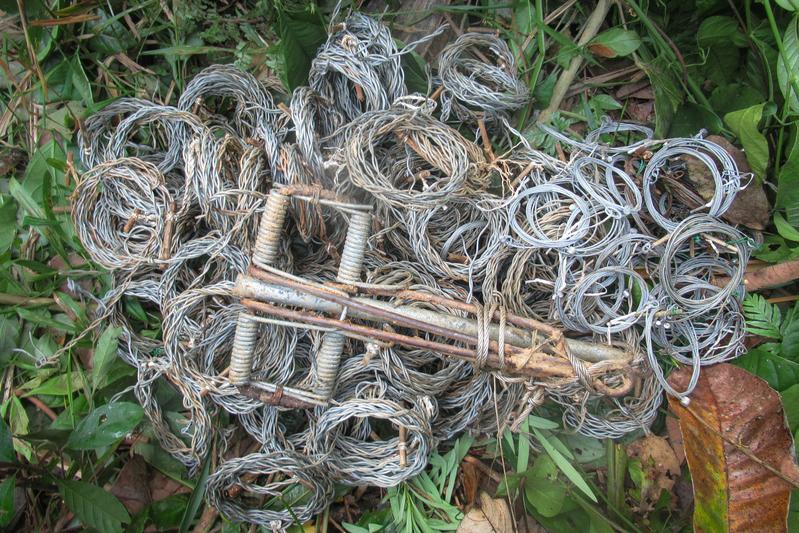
xmin=57 ymin=480 xmax=130 ymax=533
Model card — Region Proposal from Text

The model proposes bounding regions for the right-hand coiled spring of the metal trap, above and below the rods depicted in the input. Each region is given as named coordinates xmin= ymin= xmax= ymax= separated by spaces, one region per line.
xmin=314 ymin=212 xmax=372 ymax=399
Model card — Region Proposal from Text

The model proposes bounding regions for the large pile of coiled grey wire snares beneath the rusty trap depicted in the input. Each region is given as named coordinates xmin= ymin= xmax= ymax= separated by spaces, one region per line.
xmin=64 ymin=13 xmax=752 ymax=529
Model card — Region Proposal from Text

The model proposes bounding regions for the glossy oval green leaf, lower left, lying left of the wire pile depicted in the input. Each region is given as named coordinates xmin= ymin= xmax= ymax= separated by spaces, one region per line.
xmin=67 ymin=402 xmax=144 ymax=450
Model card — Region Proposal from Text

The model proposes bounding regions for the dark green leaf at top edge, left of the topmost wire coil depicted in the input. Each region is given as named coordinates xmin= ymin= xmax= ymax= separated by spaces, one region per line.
xmin=278 ymin=9 xmax=327 ymax=90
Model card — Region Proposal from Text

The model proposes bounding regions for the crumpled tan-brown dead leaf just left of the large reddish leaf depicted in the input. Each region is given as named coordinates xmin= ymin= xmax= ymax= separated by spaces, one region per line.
xmin=627 ymin=435 xmax=680 ymax=512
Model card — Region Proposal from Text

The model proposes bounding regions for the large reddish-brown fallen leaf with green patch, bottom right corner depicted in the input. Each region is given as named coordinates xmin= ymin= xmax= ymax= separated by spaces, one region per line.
xmin=669 ymin=363 xmax=799 ymax=532
